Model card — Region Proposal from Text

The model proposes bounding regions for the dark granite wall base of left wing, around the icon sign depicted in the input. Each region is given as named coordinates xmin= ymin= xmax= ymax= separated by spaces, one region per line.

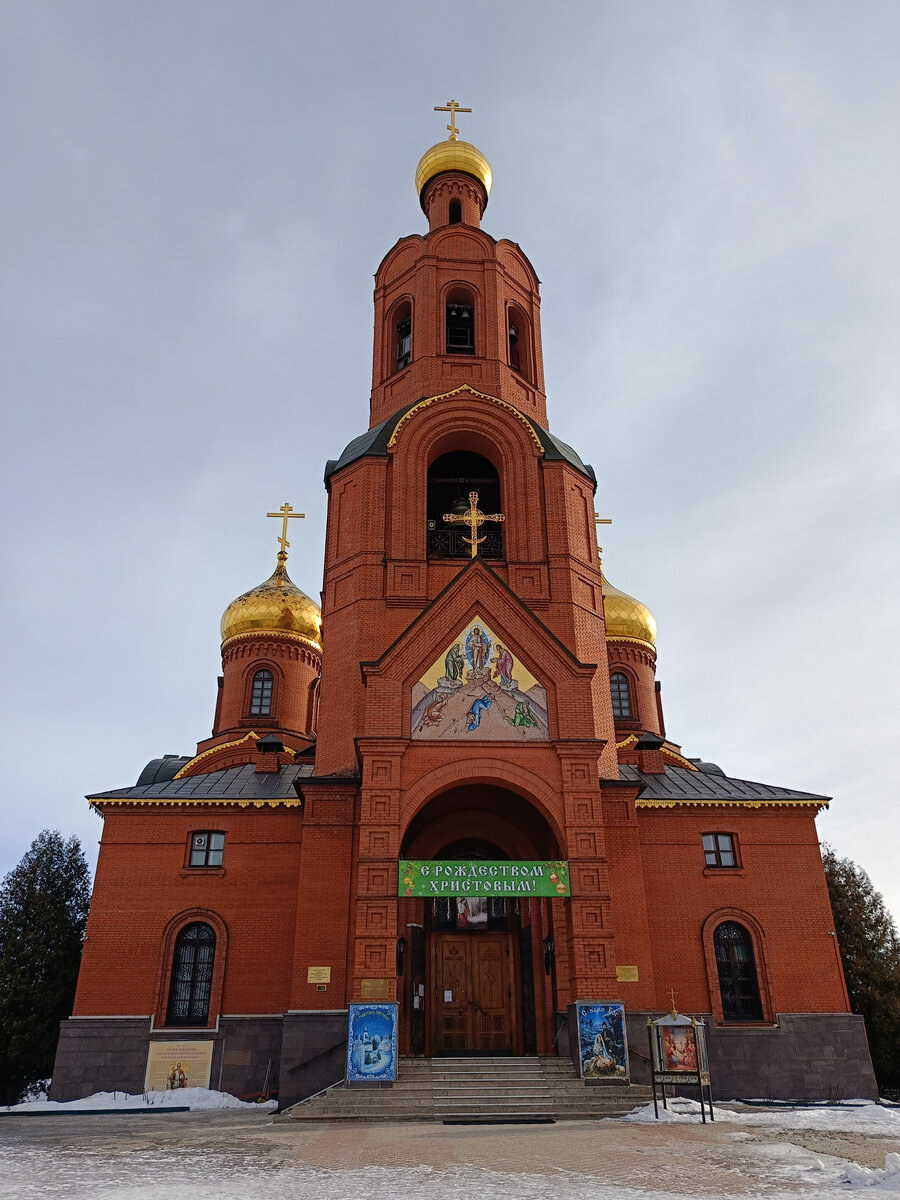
xmin=49 ymin=1015 xmax=282 ymax=1100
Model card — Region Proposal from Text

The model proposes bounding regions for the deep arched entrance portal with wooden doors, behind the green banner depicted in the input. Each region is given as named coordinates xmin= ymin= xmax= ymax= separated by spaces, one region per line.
xmin=398 ymin=784 xmax=562 ymax=1056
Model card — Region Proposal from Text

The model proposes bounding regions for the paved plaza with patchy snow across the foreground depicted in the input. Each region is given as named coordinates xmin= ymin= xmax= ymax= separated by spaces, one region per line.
xmin=0 ymin=1110 xmax=900 ymax=1200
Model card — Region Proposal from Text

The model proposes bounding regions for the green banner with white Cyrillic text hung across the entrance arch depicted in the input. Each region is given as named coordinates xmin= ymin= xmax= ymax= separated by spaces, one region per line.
xmin=397 ymin=858 xmax=571 ymax=896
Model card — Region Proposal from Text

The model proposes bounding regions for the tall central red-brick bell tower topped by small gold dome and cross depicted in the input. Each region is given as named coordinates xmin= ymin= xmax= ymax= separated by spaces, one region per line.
xmin=285 ymin=102 xmax=636 ymax=1052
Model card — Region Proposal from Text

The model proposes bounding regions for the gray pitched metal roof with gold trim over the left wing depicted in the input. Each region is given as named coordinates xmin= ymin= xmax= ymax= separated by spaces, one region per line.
xmin=88 ymin=763 xmax=313 ymax=804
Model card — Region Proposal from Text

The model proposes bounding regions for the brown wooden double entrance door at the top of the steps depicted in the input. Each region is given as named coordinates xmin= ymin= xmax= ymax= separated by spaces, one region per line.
xmin=431 ymin=932 xmax=517 ymax=1054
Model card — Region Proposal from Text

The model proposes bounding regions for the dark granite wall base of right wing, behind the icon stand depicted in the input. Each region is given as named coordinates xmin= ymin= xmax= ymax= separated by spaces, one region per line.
xmin=625 ymin=1013 xmax=878 ymax=1100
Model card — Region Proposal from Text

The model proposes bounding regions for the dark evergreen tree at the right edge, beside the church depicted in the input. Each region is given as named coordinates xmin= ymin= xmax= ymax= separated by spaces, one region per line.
xmin=822 ymin=846 xmax=900 ymax=1091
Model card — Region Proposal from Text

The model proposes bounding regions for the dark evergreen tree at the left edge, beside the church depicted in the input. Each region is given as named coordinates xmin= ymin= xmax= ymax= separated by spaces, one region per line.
xmin=0 ymin=829 xmax=91 ymax=1104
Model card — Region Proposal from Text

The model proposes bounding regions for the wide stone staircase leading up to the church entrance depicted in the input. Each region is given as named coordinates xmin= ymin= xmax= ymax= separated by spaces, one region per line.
xmin=281 ymin=1057 xmax=652 ymax=1124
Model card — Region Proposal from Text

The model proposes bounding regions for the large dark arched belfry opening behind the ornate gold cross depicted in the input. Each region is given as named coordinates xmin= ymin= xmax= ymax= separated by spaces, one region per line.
xmin=427 ymin=450 xmax=503 ymax=558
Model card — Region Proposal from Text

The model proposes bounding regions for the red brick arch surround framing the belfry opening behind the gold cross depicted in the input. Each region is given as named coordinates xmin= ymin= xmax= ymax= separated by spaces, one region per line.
xmin=389 ymin=392 xmax=545 ymax=562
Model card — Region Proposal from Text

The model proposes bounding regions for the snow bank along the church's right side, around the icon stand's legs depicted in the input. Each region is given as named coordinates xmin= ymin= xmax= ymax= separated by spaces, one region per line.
xmin=612 ymin=1096 xmax=900 ymax=1139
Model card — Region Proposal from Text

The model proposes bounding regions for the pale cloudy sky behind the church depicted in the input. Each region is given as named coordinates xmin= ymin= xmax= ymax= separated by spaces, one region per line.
xmin=0 ymin=0 xmax=900 ymax=913
